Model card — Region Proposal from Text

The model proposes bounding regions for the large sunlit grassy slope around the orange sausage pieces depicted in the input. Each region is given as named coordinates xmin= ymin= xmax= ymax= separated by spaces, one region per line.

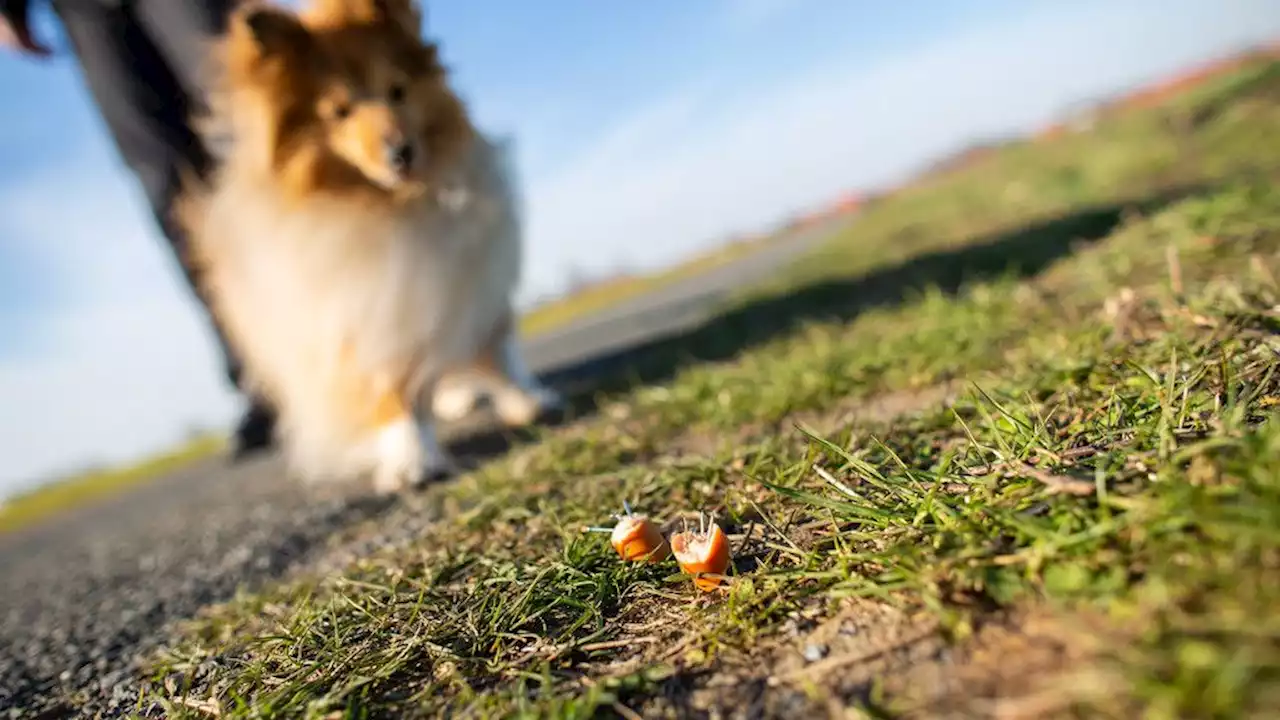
xmin=143 ymin=57 xmax=1280 ymax=717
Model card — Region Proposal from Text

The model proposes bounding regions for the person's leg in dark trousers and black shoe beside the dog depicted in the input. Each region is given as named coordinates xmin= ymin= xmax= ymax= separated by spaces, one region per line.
xmin=54 ymin=0 xmax=274 ymax=455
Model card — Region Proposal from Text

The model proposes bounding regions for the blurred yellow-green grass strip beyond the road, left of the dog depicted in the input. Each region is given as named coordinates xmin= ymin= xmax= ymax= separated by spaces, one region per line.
xmin=0 ymin=437 xmax=224 ymax=533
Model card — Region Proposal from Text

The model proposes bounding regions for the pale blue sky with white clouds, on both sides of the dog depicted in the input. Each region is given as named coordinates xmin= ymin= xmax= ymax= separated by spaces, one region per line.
xmin=0 ymin=0 xmax=1280 ymax=496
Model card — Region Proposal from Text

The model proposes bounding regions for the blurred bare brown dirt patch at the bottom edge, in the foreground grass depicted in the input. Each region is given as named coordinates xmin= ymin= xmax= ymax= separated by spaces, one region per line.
xmin=631 ymin=600 xmax=1097 ymax=720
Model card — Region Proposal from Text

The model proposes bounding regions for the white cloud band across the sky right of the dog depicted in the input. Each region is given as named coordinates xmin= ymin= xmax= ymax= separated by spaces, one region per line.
xmin=514 ymin=0 xmax=1280 ymax=297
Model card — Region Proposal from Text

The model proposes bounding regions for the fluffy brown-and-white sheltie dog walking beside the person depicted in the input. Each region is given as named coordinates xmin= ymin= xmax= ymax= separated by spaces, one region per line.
xmin=180 ymin=0 xmax=557 ymax=492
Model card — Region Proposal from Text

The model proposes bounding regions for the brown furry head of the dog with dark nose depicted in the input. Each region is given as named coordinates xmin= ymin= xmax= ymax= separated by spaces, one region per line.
xmin=230 ymin=0 xmax=470 ymax=195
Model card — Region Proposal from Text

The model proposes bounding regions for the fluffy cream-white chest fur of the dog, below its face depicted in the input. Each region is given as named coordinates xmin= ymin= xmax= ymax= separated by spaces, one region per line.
xmin=201 ymin=146 xmax=520 ymax=475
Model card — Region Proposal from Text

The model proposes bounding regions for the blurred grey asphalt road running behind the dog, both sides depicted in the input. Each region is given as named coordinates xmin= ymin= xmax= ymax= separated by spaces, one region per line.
xmin=0 ymin=215 xmax=849 ymax=717
